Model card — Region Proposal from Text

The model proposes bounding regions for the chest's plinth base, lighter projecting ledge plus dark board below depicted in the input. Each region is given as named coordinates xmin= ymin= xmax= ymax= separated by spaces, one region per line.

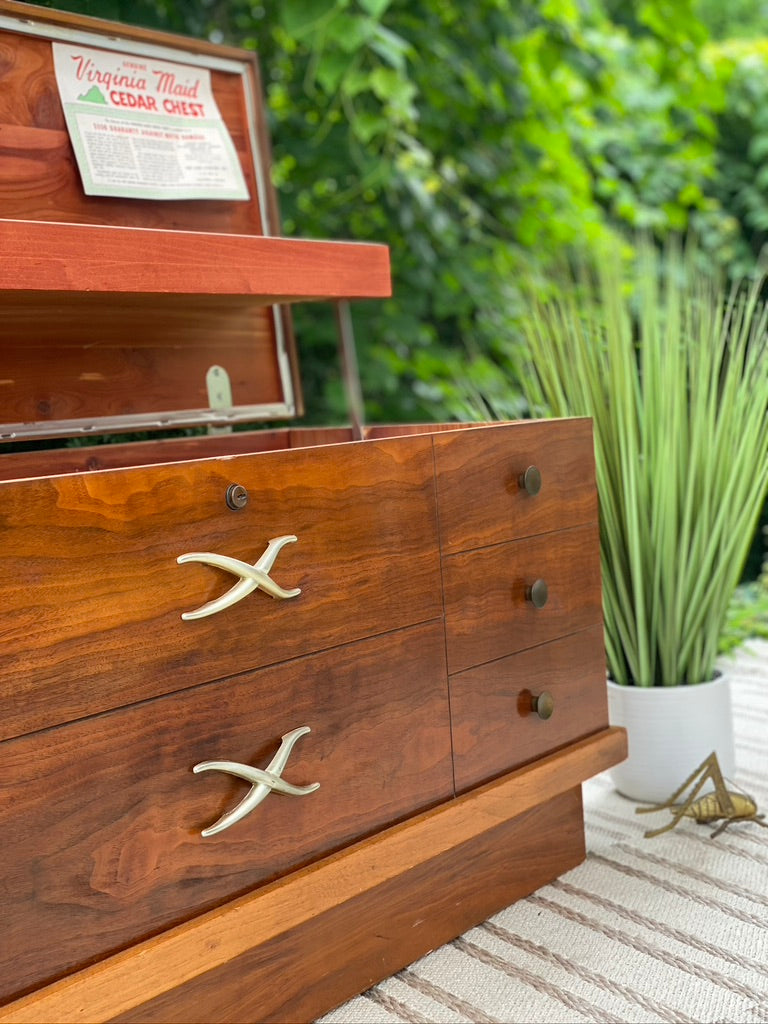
xmin=0 ymin=729 xmax=626 ymax=1024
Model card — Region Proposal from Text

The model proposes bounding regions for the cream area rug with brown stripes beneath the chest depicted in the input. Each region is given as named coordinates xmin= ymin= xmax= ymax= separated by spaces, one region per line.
xmin=322 ymin=641 xmax=768 ymax=1024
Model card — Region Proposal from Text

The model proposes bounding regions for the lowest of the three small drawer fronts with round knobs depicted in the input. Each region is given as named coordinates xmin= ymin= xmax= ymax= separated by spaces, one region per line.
xmin=451 ymin=626 xmax=608 ymax=793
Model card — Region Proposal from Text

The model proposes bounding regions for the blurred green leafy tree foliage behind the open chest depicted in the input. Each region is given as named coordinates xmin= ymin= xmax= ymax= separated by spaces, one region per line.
xmin=19 ymin=0 xmax=765 ymax=421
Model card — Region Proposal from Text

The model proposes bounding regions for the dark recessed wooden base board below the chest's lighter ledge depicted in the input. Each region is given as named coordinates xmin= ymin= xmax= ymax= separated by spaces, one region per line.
xmin=113 ymin=787 xmax=584 ymax=1024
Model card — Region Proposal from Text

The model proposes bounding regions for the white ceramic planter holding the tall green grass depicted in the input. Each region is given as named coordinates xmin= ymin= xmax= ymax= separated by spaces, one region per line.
xmin=607 ymin=675 xmax=734 ymax=803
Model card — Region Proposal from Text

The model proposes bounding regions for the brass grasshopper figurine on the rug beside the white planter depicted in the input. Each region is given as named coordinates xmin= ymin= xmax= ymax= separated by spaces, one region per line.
xmin=635 ymin=751 xmax=768 ymax=839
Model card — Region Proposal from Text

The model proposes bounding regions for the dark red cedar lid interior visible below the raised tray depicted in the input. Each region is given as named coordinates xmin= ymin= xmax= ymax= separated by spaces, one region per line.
xmin=0 ymin=292 xmax=301 ymax=430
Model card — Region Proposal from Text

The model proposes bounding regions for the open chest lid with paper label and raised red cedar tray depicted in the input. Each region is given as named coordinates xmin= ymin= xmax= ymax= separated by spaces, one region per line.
xmin=0 ymin=0 xmax=390 ymax=441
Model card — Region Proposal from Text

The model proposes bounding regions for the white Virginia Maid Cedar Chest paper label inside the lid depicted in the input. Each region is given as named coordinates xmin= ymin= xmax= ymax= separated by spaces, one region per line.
xmin=51 ymin=42 xmax=249 ymax=200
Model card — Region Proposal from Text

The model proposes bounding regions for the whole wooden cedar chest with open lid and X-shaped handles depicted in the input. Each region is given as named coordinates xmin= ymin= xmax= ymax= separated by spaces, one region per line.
xmin=0 ymin=0 xmax=625 ymax=1022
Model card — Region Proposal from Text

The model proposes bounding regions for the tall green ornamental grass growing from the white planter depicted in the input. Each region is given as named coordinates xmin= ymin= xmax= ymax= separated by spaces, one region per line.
xmin=520 ymin=241 xmax=768 ymax=686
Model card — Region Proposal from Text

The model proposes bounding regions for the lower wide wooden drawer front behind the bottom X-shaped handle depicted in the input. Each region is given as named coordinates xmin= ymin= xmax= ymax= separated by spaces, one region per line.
xmin=0 ymin=621 xmax=453 ymax=999
